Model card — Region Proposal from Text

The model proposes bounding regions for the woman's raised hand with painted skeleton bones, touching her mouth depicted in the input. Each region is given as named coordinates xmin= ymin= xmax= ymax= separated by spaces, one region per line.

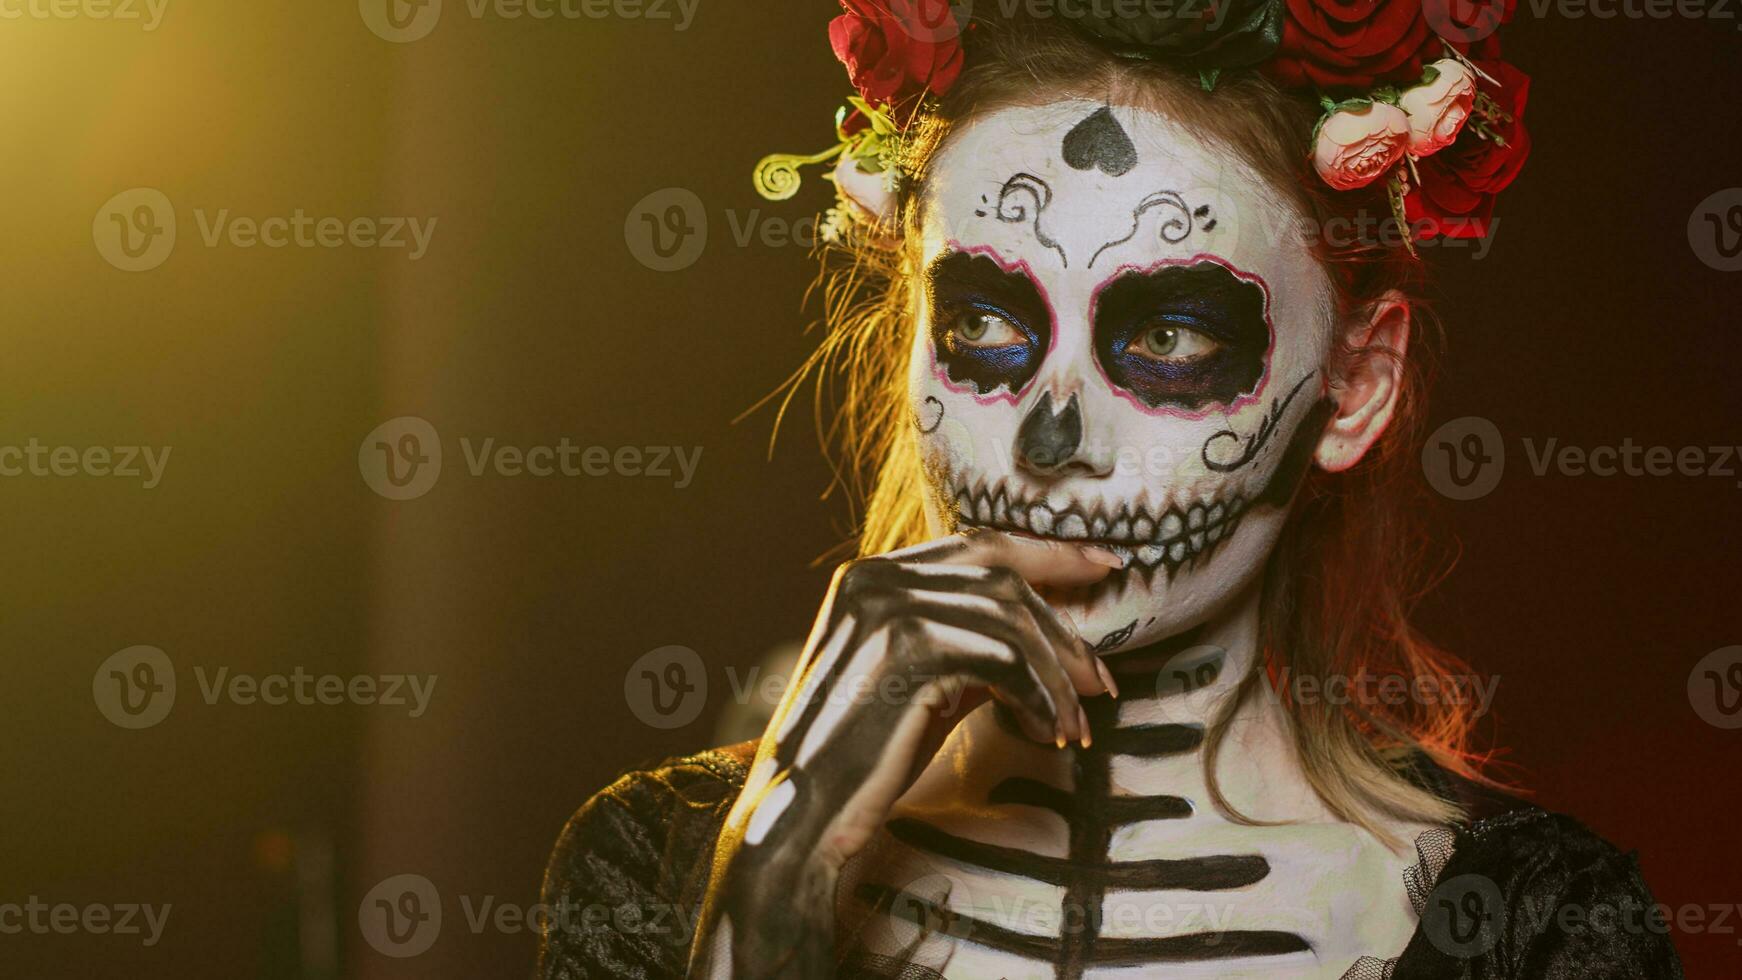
xmin=690 ymin=529 xmax=1124 ymax=980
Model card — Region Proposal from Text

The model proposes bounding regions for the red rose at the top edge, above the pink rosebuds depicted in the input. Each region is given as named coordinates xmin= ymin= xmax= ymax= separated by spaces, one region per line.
xmin=1265 ymin=0 xmax=1444 ymax=89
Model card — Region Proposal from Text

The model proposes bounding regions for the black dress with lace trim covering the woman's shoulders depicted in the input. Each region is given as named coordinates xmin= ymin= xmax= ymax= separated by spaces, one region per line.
xmin=538 ymin=743 xmax=1681 ymax=980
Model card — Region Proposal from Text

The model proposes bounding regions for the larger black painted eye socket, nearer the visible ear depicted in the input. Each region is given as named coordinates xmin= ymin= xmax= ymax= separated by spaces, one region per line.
xmin=1094 ymin=261 xmax=1270 ymax=411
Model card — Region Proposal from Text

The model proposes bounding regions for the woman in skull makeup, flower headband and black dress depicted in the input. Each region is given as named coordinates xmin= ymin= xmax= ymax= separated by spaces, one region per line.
xmin=540 ymin=7 xmax=1681 ymax=980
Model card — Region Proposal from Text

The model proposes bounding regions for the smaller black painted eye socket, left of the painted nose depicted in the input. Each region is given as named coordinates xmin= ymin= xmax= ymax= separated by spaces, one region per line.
xmin=927 ymin=252 xmax=1050 ymax=395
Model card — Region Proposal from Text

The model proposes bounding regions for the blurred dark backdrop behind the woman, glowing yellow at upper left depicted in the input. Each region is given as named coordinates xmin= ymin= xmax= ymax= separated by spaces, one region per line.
xmin=0 ymin=0 xmax=1742 ymax=978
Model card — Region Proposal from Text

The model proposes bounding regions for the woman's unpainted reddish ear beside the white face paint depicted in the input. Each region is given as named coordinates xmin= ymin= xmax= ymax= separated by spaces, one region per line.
xmin=1313 ymin=289 xmax=1411 ymax=473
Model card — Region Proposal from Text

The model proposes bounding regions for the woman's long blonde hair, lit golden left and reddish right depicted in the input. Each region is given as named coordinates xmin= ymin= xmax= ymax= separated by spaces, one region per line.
xmin=782 ymin=19 xmax=1493 ymax=839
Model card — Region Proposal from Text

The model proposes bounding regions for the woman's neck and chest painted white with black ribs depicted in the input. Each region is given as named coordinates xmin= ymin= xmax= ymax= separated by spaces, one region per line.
xmin=838 ymin=630 xmax=1435 ymax=980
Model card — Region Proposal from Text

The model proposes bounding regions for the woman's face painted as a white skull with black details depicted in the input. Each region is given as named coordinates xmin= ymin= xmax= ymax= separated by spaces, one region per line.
xmin=909 ymin=99 xmax=1334 ymax=653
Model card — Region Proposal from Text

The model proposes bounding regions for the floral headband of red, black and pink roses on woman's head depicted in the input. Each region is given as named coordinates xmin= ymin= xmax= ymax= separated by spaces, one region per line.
xmin=756 ymin=0 xmax=1529 ymax=252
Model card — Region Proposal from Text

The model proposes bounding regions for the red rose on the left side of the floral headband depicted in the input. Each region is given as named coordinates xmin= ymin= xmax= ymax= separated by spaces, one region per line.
xmin=829 ymin=0 xmax=962 ymax=125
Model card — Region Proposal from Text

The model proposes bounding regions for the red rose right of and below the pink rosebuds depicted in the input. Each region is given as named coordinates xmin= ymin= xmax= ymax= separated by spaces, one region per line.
xmin=1404 ymin=61 xmax=1529 ymax=238
